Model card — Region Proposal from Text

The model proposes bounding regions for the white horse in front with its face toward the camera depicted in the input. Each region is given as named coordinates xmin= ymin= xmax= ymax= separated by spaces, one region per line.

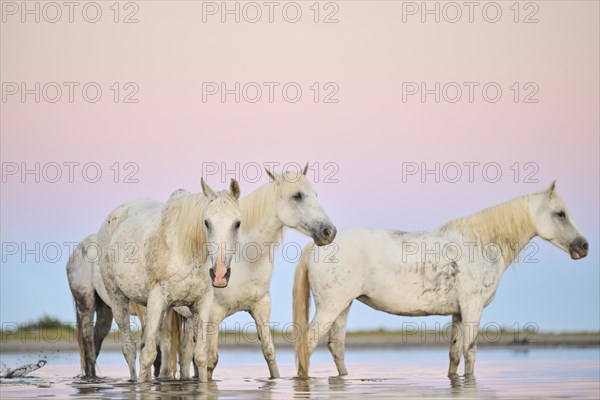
xmin=98 ymin=180 xmax=241 ymax=382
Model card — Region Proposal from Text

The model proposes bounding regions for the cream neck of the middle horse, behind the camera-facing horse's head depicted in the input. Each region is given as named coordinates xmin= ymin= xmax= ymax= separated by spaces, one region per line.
xmin=240 ymin=183 xmax=283 ymax=247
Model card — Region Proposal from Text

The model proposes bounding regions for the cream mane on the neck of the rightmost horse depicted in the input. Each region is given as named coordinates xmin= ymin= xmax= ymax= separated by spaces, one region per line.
xmin=438 ymin=196 xmax=536 ymax=266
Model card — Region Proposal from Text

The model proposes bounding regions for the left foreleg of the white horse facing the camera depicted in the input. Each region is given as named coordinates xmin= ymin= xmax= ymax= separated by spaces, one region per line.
xmin=139 ymin=285 xmax=167 ymax=382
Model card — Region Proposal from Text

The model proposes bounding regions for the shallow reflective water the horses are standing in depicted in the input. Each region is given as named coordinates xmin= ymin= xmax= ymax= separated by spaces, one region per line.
xmin=0 ymin=348 xmax=600 ymax=399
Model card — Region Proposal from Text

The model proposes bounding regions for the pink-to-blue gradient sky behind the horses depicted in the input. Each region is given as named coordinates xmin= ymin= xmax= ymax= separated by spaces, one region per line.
xmin=0 ymin=1 xmax=600 ymax=331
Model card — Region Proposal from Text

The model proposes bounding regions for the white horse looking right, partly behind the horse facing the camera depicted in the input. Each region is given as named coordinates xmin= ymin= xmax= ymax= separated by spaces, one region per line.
xmin=172 ymin=167 xmax=336 ymax=379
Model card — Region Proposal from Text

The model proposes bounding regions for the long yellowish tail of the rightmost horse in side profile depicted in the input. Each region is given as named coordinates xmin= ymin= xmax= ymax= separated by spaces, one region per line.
xmin=292 ymin=243 xmax=313 ymax=377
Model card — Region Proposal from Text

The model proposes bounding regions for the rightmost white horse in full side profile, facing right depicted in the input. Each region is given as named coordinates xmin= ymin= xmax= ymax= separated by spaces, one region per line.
xmin=293 ymin=182 xmax=588 ymax=377
